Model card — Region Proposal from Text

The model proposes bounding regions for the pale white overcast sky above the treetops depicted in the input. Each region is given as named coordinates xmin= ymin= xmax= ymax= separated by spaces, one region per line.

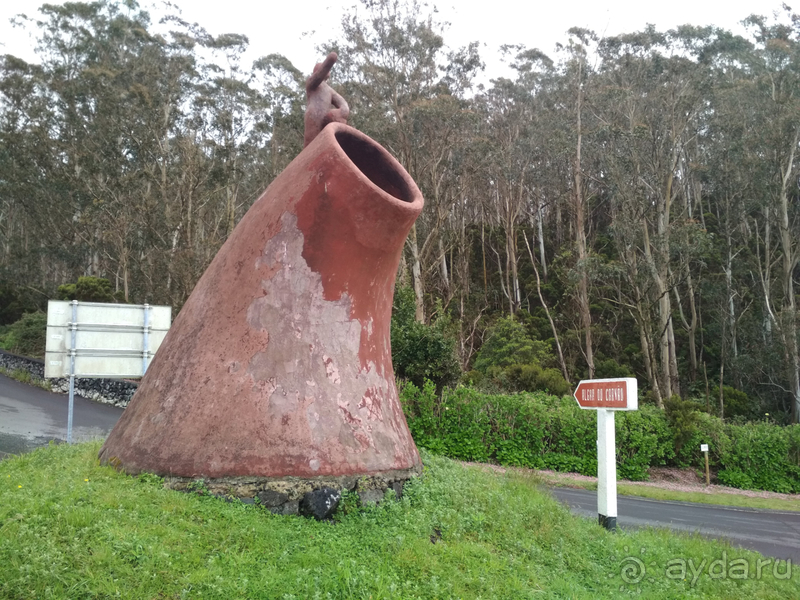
xmin=0 ymin=0 xmax=788 ymax=80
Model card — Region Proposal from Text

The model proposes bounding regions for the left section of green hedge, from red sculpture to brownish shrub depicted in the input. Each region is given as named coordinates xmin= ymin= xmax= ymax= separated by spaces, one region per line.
xmin=401 ymin=382 xmax=673 ymax=479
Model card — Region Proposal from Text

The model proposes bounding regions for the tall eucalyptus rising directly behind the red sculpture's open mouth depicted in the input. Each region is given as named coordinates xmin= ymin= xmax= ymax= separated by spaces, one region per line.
xmin=329 ymin=0 xmax=482 ymax=321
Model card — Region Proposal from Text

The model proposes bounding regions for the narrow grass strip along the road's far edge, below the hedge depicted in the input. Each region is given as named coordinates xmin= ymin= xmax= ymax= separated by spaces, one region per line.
xmin=542 ymin=476 xmax=800 ymax=512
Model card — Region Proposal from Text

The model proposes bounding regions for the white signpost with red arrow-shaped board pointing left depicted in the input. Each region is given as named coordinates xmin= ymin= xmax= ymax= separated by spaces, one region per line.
xmin=574 ymin=377 xmax=639 ymax=531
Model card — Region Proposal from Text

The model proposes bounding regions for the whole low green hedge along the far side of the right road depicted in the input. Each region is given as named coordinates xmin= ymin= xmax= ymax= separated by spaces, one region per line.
xmin=400 ymin=382 xmax=800 ymax=492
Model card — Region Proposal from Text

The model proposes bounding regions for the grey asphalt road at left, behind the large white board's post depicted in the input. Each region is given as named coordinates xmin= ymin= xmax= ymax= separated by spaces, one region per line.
xmin=0 ymin=375 xmax=123 ymax=458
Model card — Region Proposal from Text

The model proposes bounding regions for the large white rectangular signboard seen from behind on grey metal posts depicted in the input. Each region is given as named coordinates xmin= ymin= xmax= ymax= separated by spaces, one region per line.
xmin=44 ymin=300 xmax=172 ymax=443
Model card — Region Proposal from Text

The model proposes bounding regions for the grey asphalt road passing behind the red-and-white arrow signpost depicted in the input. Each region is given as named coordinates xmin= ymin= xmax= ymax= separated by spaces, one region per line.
xmin=550 ymin=488 xmax=800 ymax=565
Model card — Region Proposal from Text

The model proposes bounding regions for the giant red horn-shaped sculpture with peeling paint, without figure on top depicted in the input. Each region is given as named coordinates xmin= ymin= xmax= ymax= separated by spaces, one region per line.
xmin=100 ymin=123 xmax=423 ymax=478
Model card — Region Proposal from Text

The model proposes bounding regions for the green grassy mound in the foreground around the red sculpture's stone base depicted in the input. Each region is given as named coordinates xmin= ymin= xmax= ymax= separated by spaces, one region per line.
xmin=0 ymin=442 xmax=800 ymax=600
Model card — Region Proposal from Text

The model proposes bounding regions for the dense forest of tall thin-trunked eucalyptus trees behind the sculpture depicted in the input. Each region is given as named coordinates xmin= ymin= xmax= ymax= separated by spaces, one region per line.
xmin=0 ymin=0 xmax=800 ymax=423
